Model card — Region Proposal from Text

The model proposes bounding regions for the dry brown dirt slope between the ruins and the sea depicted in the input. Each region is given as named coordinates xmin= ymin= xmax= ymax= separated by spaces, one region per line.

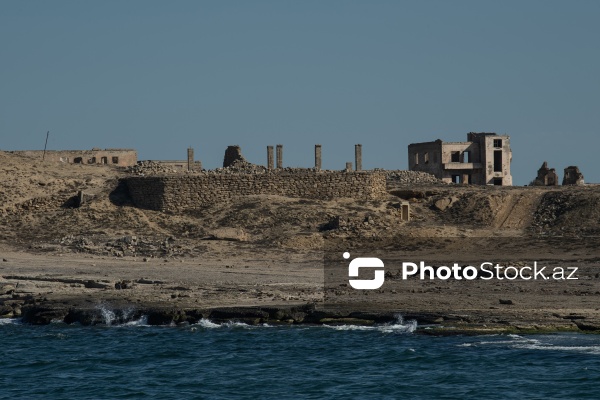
xmin=0 ymin=151 xmax=600 ymax=332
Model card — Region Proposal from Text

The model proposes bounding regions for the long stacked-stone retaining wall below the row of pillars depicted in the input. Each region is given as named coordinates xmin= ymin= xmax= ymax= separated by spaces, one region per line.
xmin=125 ymin=171 xmax=387 ymax=212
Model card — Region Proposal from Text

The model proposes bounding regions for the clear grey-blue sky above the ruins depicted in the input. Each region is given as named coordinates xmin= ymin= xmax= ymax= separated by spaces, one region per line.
xmin=0 ymin=0 xmax=600 ymax=185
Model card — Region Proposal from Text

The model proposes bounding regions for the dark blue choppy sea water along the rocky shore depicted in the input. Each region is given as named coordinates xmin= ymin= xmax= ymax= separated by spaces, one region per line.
xmin=0 ymin=319 xmax=600 ymax=399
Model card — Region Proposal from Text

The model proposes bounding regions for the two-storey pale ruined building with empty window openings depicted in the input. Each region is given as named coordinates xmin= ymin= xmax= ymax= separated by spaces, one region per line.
xmin=408 ymin=132 xmax=512 ymax=186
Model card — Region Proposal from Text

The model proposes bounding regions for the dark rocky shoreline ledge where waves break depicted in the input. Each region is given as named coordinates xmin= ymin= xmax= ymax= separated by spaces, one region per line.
xmin=2 ymin=302 xmax=600 ymax=336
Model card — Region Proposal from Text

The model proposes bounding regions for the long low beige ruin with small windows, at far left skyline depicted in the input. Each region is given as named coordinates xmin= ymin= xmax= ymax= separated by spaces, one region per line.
xmin=11 ymin=148 xmax=137 ymax=167
